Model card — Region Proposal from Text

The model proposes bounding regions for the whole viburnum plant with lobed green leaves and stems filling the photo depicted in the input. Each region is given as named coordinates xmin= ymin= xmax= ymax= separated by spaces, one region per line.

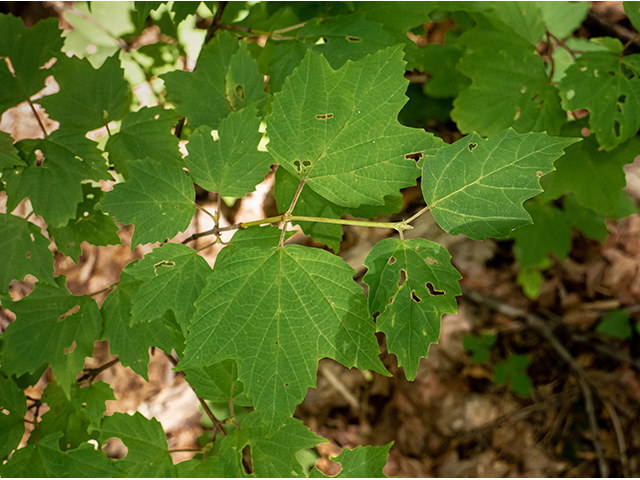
xmin=0 ymin=2 xmax=640 ymax=477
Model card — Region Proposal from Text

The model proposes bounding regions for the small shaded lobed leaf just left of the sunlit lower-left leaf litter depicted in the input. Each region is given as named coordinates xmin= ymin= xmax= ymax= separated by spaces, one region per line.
xmin=38 ymin=381 xmax=116 ymax=450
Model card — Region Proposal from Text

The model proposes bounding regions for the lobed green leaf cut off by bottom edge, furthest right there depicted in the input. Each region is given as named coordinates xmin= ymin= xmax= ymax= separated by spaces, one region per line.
xmin=309 ymin=442 xmax=393 ymax=478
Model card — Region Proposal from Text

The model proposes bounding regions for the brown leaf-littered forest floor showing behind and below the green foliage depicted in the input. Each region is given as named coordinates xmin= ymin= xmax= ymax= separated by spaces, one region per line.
xmin=0 ymin=2 xmax=640 ymax=477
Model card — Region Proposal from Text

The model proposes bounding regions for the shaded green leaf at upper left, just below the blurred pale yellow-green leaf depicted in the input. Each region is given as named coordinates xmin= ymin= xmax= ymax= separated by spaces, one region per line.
xmin=38 ymin=55 xmax=128 ymax=132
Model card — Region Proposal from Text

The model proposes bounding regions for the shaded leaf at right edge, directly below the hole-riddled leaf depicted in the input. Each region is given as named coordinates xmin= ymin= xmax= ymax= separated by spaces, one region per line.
xmin=544 ymin=122 xmax=640 ymax=216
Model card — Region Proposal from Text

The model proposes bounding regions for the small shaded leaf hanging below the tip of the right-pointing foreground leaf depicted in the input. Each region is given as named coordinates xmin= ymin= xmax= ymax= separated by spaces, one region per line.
xmin=511 ymin=201 xmax=571 ymax=269
